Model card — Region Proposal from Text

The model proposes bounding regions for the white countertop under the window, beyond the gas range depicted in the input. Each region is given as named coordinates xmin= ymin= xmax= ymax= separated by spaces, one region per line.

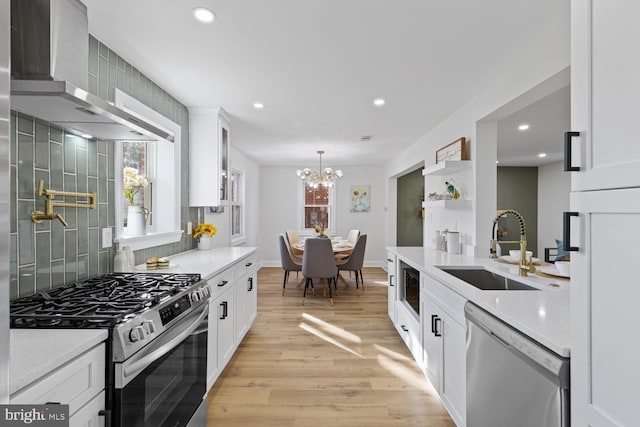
xmin=135 ymin=246 xmax=258 ymax=279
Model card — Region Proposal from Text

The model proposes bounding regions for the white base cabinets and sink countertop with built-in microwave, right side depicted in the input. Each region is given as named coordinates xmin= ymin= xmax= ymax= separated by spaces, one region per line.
xmin=387 ymin=247 xmax=570 ymax=427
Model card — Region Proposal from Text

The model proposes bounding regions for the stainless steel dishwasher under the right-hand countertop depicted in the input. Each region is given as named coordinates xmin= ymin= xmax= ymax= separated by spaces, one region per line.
xmin=464 ymin=302 xmax=570 ymax=427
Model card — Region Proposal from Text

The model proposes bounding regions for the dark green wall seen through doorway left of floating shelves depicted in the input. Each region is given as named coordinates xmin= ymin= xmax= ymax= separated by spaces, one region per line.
xmin=396 ymin=169 xmax=424 ymax=246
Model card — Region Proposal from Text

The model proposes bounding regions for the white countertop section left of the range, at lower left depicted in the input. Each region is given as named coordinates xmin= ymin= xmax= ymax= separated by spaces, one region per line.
xmin=9 ymin=329 xmax=108 ymax=394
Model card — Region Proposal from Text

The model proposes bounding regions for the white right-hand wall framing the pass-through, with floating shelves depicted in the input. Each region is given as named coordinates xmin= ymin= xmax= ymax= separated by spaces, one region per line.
xmin=385 ymin=23 xmax=570 ymax=256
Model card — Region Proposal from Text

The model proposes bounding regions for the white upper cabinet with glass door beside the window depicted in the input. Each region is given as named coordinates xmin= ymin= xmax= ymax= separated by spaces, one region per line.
xmin=189 ymin=108 xmax=231 ymax=206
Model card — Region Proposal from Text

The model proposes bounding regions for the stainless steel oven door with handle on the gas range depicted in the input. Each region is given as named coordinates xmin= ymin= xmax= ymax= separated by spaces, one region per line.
xmin=114 ymin=304 xmax=208 ymax=427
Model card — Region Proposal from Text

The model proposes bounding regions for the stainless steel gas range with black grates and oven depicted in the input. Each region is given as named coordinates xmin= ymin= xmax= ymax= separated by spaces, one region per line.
xmin=10 ymin=273 xmax=210 ymax=427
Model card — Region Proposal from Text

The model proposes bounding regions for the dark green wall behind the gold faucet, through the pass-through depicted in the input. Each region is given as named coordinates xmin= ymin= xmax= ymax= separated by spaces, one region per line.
xmin=497 ymin=167 xmax=544 ymax=259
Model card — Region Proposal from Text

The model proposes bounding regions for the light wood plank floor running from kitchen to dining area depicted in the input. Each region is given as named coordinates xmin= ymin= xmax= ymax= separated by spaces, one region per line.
xmin=208 ymin=268 xmax=454 ymax=427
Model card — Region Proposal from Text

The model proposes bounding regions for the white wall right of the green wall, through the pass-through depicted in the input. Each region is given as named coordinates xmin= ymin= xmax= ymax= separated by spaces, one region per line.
xmin=538 ymin=162 xmax=571 ymax=252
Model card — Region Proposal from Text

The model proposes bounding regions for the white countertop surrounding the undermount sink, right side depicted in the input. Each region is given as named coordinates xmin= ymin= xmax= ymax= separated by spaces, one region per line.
xmin=387 ymin=247 xmax=571 ymax=357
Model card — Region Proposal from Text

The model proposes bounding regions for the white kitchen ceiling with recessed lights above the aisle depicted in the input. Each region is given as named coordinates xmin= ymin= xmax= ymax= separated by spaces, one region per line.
xmin=83 ymin=0 xmax=568 ymax=166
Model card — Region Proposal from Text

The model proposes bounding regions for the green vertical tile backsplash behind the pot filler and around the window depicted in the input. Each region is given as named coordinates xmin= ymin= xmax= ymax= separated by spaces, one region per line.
xmin=9 ymin=36 xmax=198 ymax=299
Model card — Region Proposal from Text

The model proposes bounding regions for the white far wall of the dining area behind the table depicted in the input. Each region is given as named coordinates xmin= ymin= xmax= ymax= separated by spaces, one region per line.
xmin=256 ymin=165 xmax=386 ymax=266
